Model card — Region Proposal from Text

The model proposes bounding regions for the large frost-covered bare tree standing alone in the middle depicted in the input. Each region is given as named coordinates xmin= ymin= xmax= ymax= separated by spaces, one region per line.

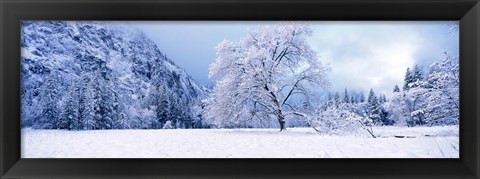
xmin=205 ymin=23 xmax=329 ymax=131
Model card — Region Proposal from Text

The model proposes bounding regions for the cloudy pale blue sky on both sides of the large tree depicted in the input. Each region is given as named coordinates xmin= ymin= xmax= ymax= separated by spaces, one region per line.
xmin=129 ymin=21 xmax=459 ymax=95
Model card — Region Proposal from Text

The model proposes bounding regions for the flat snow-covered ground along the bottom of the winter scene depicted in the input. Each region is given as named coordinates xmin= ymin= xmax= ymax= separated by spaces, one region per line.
xmin=22 ymin=126 xmax=459 ymax=158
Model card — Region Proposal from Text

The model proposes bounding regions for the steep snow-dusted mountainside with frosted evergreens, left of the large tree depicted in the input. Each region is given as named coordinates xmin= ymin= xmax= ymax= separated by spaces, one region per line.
xmin=21 ymin=21 xmax=208 ymax=130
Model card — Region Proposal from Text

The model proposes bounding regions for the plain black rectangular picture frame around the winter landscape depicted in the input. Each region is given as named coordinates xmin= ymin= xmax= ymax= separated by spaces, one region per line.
xmin=0 ymin=0 xmax=480 ymax=178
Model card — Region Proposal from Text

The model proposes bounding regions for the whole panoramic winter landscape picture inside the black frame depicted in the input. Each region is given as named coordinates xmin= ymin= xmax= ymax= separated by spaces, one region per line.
xmin=21 ymin=21 xmax=460 ymax=158
